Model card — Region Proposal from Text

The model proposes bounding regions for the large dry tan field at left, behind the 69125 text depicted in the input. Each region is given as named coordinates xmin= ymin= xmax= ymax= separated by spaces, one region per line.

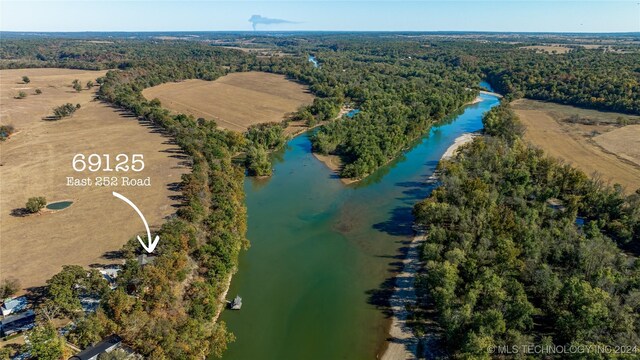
xmin=0 ymin=69 xmax=190 ymax=289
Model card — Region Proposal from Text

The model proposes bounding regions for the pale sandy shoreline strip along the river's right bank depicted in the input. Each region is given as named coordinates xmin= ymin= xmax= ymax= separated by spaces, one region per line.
xmin=380 ymin=133 xmax=479 ymax=360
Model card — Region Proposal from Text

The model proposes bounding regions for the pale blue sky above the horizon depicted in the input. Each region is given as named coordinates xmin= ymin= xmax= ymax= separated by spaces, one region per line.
xmin=0 ymin=0 xmax=640 ymax=32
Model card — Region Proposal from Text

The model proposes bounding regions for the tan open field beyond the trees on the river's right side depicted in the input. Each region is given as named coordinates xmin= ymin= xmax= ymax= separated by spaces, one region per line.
xmin=512 ymin=99 xmax=640 ymax=193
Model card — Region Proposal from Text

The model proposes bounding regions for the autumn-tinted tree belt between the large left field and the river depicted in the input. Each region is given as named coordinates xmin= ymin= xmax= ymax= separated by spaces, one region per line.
xmin=85 ymin=67 xmax=248 ymax=359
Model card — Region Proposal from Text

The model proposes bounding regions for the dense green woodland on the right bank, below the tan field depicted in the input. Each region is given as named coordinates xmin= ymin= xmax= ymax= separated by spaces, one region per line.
xmin=414 ymin=105 xmax=640 ymax=358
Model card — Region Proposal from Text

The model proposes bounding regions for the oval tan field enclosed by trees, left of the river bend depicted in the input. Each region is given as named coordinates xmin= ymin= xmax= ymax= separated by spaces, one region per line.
xmin=142 ymin=72 xmax=313 ymax=132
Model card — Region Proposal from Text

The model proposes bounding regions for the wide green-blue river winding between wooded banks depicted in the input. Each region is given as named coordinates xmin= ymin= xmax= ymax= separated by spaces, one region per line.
xmin=222 ymin=94 xmax=498 ymax=360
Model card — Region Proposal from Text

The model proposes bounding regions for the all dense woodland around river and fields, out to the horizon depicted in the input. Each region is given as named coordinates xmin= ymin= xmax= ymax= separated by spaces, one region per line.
xmin=0 ymin=34 xmax=640 ymax=359
